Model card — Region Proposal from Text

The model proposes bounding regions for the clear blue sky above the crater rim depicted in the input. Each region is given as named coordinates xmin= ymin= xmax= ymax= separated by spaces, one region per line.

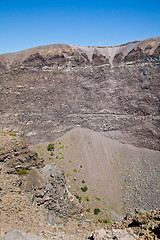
xmin=0 ymin=0 xmax=160 ymax=53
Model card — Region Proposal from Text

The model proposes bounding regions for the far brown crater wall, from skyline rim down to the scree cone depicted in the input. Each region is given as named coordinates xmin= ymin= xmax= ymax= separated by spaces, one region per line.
xmin=0 ymin=38 xmax=160 ymax=150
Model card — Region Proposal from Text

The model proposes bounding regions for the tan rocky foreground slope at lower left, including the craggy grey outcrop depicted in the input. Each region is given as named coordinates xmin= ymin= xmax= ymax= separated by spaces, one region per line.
xmin=0 ymin=132 xmax=91 ymax=240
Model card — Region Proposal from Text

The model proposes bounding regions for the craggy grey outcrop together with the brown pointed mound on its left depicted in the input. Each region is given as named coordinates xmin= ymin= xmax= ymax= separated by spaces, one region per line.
xmin=22 ymin=165 xmax=81 ymax=225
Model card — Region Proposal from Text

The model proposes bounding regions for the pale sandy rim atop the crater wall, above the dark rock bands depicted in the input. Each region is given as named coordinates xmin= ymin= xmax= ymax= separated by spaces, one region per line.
xmin=0 ymin=37 xmax=160 ymax=68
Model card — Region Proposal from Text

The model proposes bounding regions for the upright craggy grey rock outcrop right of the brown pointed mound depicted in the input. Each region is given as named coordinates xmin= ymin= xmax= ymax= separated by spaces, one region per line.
xmin=32 ymin=165 xmax=68 ymax=224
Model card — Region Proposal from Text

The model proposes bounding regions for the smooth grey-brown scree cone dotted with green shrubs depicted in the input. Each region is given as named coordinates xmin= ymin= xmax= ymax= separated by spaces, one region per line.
xmin=32 ymin=128 xmax=160 ymax=221
